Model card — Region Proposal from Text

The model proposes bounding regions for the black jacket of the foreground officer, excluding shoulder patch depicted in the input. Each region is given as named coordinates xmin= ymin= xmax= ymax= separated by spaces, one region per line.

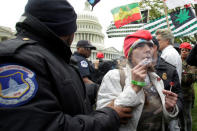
xmin=0 ymin=13 xmax=119 ymax=131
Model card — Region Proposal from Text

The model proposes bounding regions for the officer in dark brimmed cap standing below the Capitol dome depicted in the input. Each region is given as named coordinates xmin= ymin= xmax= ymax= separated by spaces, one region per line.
xmin=70 ymin=40 xmax=99 ymax=106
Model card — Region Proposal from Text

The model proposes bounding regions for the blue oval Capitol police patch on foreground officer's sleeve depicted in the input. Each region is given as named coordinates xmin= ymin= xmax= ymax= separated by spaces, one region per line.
xmin=0 ymin=64 xmax=38 ymax=107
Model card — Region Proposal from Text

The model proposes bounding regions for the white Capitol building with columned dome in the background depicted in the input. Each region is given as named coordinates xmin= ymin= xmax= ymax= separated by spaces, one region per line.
xmin=71 ymin=2 xmax=121 ymax=60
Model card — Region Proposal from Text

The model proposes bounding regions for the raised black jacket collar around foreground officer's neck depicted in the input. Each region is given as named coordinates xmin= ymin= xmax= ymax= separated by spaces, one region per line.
xmin=16 ymin=14 xmax=72 ymax=63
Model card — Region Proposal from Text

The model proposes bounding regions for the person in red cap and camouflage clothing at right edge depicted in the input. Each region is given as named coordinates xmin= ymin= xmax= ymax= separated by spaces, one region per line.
xmin=179 ymin=42 xmax=197 ymax=131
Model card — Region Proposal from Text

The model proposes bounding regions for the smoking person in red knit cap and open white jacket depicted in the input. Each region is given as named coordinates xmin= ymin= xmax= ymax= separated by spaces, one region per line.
xmin=97 ymin=30 xmax=179 ymax=131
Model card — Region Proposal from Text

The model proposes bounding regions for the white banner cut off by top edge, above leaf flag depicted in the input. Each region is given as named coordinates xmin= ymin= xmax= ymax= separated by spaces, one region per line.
xmin=164 ymin=0 xmax=194 ymax=9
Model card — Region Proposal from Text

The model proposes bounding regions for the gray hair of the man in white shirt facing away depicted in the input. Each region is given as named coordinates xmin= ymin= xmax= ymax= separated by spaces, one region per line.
xmin=156 ymin=29 xmax=174 ymax=45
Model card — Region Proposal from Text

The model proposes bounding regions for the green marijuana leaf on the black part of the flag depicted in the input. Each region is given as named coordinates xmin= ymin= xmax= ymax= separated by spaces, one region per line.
xmin=176 ymin=9 xmax=190 ymax=24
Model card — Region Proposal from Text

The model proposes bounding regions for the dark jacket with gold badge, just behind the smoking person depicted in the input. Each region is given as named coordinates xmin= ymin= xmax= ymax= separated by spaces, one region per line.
xmin=155 ymin=56 xmax=183 ymax=111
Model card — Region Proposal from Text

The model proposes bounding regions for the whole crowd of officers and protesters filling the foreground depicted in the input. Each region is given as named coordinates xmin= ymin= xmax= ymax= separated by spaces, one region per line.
xmin=0 ymin=0 xmax=197 ymax=131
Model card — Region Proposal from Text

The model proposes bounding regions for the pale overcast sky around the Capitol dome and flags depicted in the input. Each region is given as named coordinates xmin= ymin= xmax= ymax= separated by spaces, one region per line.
xmin=0 ymin=0 xmax=142 ymax=50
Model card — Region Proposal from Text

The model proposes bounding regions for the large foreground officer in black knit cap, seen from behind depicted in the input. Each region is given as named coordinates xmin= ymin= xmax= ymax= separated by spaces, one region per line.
xmin=0 ymin=0 xmax=131 ymax=131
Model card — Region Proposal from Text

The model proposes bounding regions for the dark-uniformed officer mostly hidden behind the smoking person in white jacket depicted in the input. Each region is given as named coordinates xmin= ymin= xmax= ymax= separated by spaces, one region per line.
xmin=152 ymin=37 xmax=183 ymax=131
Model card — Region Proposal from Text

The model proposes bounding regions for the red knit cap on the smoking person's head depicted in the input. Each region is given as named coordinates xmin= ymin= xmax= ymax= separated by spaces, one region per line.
xmin=124 ymin=30 xmax=152 ymax=57
